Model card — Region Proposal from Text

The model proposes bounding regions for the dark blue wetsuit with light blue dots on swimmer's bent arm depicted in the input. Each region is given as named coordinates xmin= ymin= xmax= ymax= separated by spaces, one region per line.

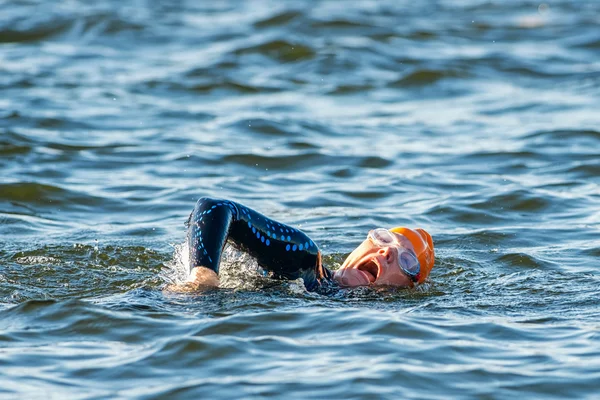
xmin=188 ymin=197 xmax=333 ymax=291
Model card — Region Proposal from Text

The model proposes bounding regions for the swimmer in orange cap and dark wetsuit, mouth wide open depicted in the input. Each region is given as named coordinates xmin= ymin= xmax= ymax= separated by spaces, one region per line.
xmin=167 ymin=197 xmax=434 ymax=292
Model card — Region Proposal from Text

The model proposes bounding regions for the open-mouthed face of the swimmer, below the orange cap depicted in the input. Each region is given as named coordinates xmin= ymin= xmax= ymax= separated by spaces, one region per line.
xmin=334 ymin=232 xmax=414 ymax=287
